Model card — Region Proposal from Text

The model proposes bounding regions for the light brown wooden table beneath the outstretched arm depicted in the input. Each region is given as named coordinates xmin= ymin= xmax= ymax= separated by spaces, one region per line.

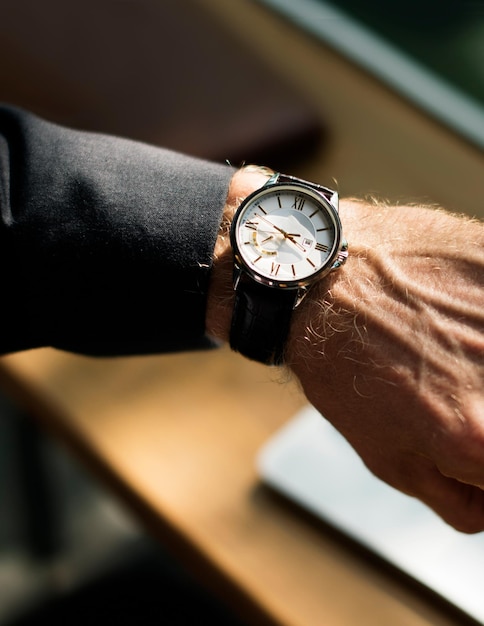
xmin=0 ymin=0 xmax=484 ymax=626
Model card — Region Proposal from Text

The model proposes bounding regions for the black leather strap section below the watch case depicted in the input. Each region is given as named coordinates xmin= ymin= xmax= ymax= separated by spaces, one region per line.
xmin=230 ymin=275 xmax=298 ymax=365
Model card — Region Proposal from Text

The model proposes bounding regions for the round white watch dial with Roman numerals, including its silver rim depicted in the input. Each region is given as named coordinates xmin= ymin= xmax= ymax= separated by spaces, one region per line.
xmin=231 ymin=183 xmax=341 ymax=288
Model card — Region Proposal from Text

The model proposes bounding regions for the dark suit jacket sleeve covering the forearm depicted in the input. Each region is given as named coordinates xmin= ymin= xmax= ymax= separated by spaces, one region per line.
xmin=0 ymin=107 xmax=233 ymax=355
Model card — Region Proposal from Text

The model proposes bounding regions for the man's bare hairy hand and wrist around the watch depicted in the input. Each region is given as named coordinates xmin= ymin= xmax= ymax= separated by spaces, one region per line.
xmin=208 ymin=167 xmax=484 ymax=532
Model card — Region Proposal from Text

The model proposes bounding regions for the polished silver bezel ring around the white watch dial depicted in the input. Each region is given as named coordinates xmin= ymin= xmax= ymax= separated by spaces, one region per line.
xmin=230 ymin=182 xmax=344 ymax=289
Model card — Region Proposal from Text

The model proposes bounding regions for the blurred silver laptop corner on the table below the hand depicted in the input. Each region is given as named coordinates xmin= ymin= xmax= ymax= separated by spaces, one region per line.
xmin=257 ymin=406 xmax=484 ymax=624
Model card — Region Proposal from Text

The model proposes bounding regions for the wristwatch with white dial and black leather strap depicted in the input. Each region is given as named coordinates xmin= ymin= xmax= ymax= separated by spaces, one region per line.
xmin=230 ymin=173 xmax=348 ymax=365
